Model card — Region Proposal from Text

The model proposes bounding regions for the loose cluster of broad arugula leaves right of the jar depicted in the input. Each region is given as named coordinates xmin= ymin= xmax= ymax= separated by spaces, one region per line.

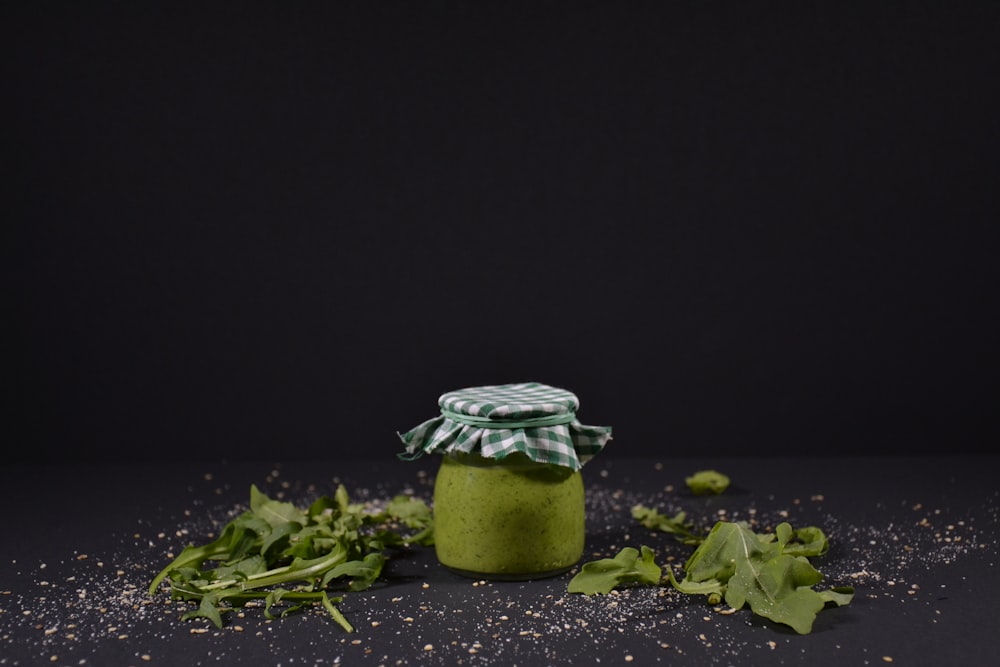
xmin=568 ymin=479 xmax=854 ymax=634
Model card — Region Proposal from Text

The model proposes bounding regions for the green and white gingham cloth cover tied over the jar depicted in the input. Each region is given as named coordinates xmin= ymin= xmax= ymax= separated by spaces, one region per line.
xmin=398 ymin=382 xmax=611 ymax=470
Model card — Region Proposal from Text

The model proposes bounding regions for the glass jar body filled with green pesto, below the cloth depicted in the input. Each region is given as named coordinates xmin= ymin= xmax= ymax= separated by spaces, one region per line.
xmin=434 ymin=453 xmax=586 ymax=580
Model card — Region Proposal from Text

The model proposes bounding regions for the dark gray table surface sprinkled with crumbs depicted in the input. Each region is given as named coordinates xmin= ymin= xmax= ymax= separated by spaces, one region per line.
xmin=0 ymin=456 xmax=1000 ymax=667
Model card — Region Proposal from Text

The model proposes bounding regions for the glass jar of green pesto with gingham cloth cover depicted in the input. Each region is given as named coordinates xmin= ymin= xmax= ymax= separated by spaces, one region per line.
xmin=398 ymin=382 xmax=611 ymax=580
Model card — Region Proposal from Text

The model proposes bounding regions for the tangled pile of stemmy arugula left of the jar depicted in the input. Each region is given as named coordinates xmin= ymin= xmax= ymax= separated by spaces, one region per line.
xmin=149 ymin=485 xmax=434 ymax=632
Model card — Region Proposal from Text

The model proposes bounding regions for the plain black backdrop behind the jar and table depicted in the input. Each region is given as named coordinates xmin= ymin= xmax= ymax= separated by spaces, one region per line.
xmin=2 ymin=2 xmax=1000 ymax=461
